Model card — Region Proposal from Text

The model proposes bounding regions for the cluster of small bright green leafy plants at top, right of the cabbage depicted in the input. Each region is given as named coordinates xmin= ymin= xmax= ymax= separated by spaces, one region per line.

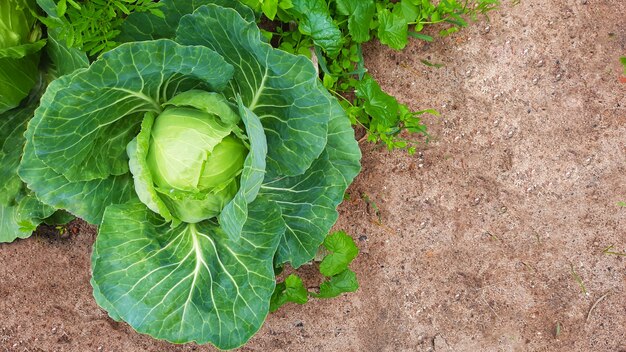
xmin=249 ymin=0 xmax=500 ymax=154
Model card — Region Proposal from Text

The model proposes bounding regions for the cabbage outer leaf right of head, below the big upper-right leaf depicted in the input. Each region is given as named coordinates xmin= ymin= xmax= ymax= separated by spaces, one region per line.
xmin=260 ymin=91 xmax=361 ymax=268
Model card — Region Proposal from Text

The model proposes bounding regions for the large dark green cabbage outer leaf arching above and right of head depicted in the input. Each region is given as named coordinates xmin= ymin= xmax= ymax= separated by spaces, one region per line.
xmin=176 ymin=5 xmax=330 ymax=177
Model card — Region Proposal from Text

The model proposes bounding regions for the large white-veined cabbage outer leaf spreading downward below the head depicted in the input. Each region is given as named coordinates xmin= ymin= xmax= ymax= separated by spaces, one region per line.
xmin=92 ymin=199 xmax=285 ymax=349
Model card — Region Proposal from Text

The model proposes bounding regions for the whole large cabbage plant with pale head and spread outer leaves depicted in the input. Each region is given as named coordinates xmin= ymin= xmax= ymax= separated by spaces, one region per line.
xmin=19 ymin=0 xmax=361 ymax=349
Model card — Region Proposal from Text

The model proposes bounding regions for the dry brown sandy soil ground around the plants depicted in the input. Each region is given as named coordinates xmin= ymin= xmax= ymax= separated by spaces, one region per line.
xmin=0 ymin=0 xmax=626 ymax=352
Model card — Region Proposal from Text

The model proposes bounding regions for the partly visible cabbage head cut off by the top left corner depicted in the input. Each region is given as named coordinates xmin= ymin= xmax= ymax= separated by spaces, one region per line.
xmin=0 ymin=0 xmax=45 ymax=113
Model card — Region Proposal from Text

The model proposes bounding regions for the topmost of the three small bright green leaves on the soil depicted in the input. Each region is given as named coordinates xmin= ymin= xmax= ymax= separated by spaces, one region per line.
xmin=320 ymin=231 xmax=359 ymax=276
